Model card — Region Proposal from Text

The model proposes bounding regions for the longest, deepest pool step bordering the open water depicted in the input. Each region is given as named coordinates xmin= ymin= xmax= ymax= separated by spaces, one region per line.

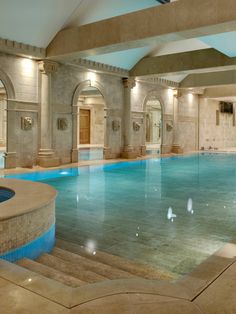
xmin=56 ymin=239 xmax=174 ymax=280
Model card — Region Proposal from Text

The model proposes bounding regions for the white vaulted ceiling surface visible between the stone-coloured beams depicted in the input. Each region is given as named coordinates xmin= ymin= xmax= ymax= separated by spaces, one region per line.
xmin=0 ymin=0 xmax=236 ymax=82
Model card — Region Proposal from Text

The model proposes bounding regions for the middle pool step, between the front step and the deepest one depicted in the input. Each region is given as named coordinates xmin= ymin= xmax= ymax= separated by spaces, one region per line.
xmin=36 ymin=254 xmax=108 ymax=283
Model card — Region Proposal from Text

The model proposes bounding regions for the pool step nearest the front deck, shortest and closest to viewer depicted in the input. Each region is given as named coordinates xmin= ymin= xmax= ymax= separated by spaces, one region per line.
xmin=16 ymin=258 xmax=87 ymax=288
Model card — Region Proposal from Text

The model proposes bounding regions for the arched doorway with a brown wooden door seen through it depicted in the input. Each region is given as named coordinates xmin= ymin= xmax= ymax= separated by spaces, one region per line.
xmin=77 ymin=86 xmax=105 ymax=160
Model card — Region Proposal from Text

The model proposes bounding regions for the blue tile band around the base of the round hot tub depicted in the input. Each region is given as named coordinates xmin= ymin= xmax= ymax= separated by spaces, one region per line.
xmin=0 ymin=224 xmax=55 ymax=262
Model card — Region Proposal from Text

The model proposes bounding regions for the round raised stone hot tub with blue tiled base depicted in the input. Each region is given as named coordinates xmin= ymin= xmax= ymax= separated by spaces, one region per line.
xmin=0 ymin=179 xmax=57 ymax=262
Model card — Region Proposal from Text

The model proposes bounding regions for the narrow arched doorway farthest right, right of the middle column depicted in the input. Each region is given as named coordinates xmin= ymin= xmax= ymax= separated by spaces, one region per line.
xmin=145 ymin=96 xmax=162 ymax=155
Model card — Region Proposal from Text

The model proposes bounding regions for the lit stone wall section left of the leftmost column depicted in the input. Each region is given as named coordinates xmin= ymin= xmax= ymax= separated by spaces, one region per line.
xmin=0 ymin=53 xmax=39 ymax=168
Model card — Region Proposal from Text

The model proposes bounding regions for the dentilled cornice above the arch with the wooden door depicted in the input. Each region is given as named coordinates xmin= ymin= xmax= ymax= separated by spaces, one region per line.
xmin=67 ymin=58 xmax=129 ymax=77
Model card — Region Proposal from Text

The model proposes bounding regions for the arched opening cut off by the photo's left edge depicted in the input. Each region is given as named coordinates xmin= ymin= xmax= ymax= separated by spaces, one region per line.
xmin=0 ymin=80 xmax=7 ymax=168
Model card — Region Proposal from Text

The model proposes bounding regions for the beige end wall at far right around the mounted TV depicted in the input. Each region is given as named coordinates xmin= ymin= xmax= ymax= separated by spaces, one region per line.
xmin=199 ymin=98 xmax=236 ymax=149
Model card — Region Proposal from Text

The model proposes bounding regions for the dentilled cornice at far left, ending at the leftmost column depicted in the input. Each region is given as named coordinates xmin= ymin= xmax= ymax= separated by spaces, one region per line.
xmin=0 ymin=38 xmax=46 ymax=59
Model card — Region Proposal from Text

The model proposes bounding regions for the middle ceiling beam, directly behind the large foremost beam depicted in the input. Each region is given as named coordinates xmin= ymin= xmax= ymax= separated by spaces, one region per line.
xmin=130 ymin=48 xmax=236 ymax=76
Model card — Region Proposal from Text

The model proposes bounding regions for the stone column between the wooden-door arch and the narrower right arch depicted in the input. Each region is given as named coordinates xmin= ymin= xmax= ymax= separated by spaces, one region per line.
xmin=122 ymin=78 xmax=137 ymax=159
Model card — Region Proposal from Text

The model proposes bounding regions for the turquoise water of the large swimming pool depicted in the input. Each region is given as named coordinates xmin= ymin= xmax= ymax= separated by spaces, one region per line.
xmin=6 ymin=154 xmax=236 ymax=276
